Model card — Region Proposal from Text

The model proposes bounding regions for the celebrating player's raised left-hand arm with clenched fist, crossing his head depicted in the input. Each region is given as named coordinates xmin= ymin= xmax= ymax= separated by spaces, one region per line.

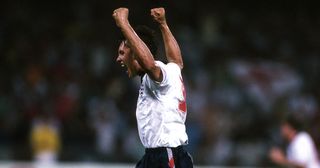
xmin=112 ymin=8 xmax=162 ymax=81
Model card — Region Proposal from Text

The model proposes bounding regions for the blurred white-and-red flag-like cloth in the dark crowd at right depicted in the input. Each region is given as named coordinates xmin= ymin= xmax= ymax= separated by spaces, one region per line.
xmin=230 ymin=60 xmax=302 ymax=112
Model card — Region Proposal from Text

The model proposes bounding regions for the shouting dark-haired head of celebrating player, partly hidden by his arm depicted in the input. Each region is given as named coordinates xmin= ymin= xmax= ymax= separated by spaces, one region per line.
xmin=116 ymin=26 xmax=158 ymax=77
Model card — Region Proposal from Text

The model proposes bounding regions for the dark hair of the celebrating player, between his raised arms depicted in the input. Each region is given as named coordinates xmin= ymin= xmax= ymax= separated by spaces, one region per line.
xmin=122 ymin=25 xmax=158 ymax=57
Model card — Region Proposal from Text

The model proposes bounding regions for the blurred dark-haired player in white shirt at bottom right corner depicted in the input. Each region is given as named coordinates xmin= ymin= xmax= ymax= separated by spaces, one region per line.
xmin=269 ymin=115 xmax=320 ymax=168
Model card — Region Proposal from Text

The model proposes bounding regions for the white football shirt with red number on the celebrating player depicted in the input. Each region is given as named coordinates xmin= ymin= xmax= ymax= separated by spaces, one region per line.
xmin=136 ymin=61 xmax=188 ymax=148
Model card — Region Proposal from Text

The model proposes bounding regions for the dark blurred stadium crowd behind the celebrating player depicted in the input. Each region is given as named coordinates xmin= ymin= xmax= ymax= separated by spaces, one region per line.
xmin=0 ymin=0 xmax=320 ymax=167
